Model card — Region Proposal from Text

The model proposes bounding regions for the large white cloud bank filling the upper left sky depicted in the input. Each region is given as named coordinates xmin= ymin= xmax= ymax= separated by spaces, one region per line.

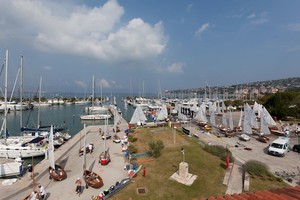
xmin=0 ymin=0 xmax=167 ymax=62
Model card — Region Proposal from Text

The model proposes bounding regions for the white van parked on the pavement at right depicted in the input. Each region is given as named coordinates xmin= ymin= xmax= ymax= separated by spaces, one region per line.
xmin=268 ymin=137 xmax=291 ymax=157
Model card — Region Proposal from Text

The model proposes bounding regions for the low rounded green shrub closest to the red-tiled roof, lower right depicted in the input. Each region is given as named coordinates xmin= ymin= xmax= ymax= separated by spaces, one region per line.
xmin=245 ymin=160 xmax=270 ymax=177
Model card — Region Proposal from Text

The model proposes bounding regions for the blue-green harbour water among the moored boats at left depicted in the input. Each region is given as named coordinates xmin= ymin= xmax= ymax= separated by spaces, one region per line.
xmin=0 ymin=94 xmax=134 ymax=137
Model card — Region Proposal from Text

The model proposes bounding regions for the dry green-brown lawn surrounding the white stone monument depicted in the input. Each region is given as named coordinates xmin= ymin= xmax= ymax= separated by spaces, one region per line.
xmin=112 ymin=127 xmax=226 ymax=200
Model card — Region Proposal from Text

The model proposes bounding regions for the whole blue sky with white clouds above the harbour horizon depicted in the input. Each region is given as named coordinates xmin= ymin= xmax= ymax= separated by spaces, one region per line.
xmin=0 ymin=0 xmax=300 ymax=95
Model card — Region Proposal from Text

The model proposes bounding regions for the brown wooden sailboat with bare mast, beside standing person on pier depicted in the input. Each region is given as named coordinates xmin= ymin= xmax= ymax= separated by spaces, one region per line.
xmin=83 ymin=124 xmax=103 ymax=188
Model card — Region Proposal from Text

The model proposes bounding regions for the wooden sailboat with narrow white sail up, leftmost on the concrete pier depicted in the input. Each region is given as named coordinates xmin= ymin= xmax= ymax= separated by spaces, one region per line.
xmin=48 ymin=126 xmax=67 ymax=181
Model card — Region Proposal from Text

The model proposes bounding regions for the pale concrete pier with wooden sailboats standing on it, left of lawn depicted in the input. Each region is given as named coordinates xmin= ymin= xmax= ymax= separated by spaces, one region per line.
xmin=0 ymin=108 xmax=128 ymax=200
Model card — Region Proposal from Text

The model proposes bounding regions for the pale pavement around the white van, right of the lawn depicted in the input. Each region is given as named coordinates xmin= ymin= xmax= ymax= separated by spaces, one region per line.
xmin=188 ymin=126 xmax=300 ymax=194
